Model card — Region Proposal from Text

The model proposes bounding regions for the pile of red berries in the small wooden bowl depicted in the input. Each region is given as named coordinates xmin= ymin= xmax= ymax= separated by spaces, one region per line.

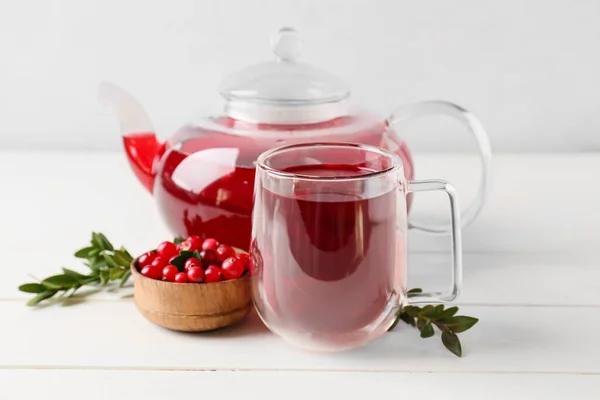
xmin=137 ymin=236 xmax=249 ymax=283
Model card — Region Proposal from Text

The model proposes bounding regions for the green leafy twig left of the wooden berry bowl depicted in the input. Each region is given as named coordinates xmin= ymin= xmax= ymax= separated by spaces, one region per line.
xmin=19 ymin=232 xmax=133 ymax=306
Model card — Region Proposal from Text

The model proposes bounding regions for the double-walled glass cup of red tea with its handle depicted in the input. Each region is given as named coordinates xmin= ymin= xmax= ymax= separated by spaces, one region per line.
xmin=250 ymin=143 xmax=462 ymax=351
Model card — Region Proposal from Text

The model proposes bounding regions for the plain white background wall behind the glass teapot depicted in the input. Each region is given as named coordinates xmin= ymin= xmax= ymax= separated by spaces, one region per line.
xmin=0 ymin=0 xmax=600 ymax=152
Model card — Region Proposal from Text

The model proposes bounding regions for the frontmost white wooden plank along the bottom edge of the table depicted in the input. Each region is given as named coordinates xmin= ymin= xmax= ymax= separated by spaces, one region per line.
xmin=0 ymin=370 xmax=600 ymax=400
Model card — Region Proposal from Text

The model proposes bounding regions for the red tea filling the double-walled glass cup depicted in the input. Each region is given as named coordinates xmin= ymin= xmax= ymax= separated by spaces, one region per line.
xmin=255 ymin=164 xmax=403 ymax=340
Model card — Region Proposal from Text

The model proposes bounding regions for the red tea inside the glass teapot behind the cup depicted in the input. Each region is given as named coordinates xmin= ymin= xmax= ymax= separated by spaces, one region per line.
xmin=123 ymin=120 xmax=413 ymax=250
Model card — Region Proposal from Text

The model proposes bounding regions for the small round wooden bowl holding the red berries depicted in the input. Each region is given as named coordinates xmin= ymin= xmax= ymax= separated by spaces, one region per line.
xmin=130 ymin=259 xmax=252 ymax=332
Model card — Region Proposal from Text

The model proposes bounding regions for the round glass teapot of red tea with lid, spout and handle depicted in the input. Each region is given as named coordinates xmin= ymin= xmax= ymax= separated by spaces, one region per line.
xmin=99 ymin=28 xmax=491 ymax=249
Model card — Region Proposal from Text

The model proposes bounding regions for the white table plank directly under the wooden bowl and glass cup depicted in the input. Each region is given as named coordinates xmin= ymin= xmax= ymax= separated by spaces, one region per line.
xmin=0 ymin=302 xmax=600 ymax=374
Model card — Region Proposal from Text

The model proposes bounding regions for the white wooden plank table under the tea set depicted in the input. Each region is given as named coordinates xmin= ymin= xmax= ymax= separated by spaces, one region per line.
xmin=0 ymin=152 xmax=600 ymax=400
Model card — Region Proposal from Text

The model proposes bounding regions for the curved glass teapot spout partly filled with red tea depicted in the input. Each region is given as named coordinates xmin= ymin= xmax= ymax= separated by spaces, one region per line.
xmin=98 ymin=82 xmax=164 ymax=193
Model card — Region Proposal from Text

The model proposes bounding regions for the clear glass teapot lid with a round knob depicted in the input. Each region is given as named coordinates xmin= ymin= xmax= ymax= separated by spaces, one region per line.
xmin=219 ymin=28 xmax=350 ymax=123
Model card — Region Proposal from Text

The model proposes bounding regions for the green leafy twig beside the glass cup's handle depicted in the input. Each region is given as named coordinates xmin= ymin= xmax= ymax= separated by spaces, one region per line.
xmin=389 ymin=288 xmax=479 ymax=357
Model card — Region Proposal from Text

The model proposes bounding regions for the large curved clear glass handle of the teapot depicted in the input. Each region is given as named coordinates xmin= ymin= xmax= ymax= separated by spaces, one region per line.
xmin=386 ymin=100 xmax=492 ymax=234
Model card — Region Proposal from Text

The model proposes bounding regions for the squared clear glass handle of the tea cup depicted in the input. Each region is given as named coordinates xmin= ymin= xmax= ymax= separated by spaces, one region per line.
xmin=405 ymin=180 xmax=462 ymax=304
